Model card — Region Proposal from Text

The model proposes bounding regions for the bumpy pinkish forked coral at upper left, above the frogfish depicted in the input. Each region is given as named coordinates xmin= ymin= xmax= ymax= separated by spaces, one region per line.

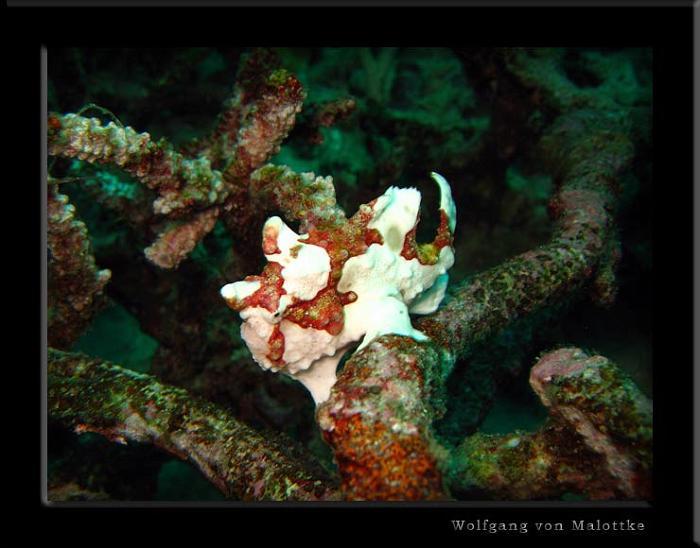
xmin=48 ymin=50 xmax=304 ymax=268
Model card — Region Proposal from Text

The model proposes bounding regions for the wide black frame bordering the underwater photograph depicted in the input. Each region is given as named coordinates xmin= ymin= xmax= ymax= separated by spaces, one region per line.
xmin=12 ymin=5 xmax=693 ymax=547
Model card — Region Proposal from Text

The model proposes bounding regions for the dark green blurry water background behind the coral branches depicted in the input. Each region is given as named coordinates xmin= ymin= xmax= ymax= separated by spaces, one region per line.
xmin=48 ymin=48 xmax=653 ymax=501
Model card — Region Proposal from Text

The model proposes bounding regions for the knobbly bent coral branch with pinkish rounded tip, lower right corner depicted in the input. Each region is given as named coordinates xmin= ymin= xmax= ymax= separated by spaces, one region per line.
xmin=450 ymin=348 xmax=652 ymax=499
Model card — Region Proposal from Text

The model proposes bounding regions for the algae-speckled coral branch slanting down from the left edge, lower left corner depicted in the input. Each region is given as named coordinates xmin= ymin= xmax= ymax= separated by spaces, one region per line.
xmin=48 ymin=349 xmax=337 ymax=500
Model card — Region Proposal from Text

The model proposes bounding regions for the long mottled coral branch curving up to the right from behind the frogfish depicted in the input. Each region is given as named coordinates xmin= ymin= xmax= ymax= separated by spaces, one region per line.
xmin=417 ymin=111 xmax=633 ymax=355
